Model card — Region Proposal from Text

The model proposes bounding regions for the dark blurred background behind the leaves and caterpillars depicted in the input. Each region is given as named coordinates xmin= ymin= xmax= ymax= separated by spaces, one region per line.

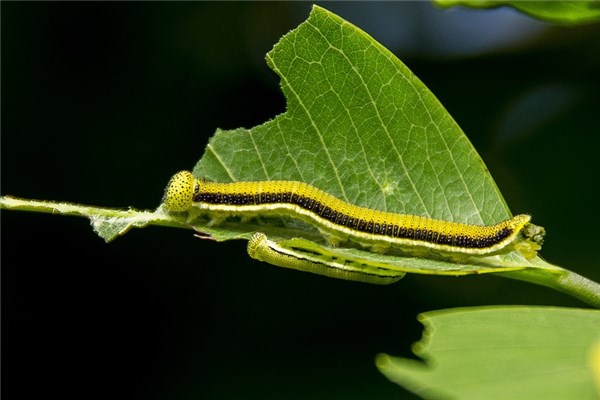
xmin=1 ymin=2 xmax=600 ymax=399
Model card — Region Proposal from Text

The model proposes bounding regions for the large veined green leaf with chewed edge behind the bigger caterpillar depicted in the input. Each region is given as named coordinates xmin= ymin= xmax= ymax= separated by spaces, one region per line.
xmin=193 ymin=6 xmax=538 ymax=274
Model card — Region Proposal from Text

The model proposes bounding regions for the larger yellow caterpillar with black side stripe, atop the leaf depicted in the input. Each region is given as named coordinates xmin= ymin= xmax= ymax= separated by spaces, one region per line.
xmin=163 ymin=171 xmax=545 ymax=258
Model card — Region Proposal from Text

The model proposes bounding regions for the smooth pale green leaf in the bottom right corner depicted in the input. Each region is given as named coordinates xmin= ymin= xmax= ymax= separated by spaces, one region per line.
xmin=377 ymin=307 xmax=600 ymax=400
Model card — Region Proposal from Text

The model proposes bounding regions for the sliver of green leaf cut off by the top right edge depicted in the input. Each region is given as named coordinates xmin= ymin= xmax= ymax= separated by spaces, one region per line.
xmin=434 ymin=0 xmax=600 ymax=24
